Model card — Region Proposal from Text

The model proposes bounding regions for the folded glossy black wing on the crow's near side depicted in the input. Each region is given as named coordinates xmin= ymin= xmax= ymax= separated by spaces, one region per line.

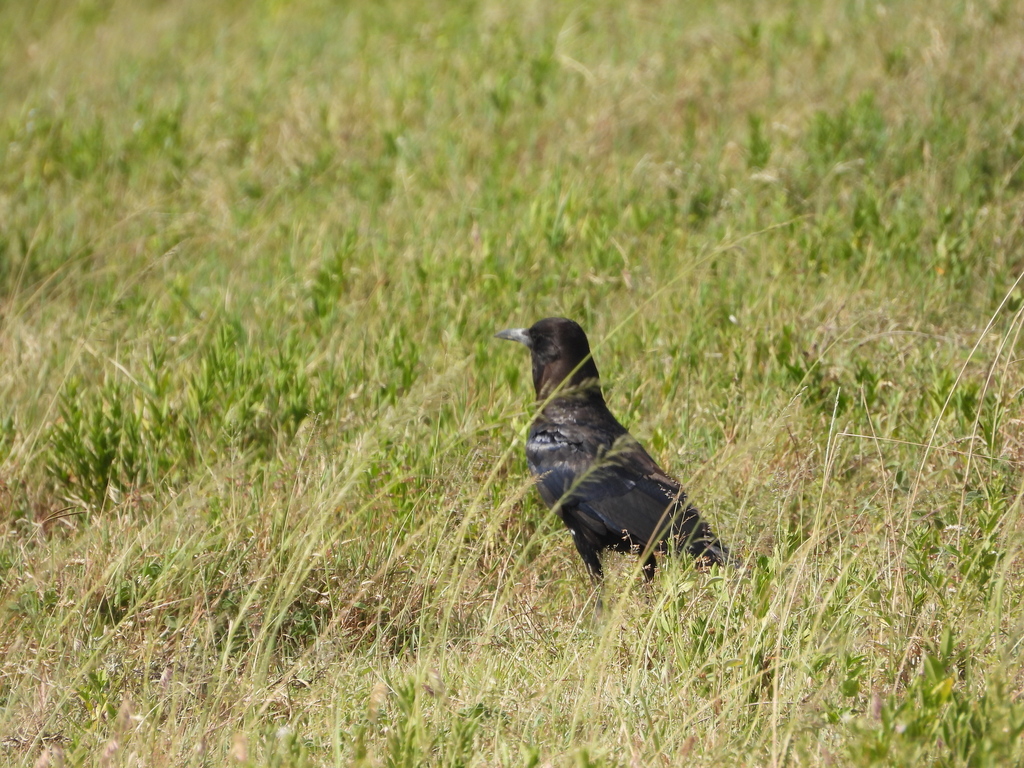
xmin=526 ymin=424 xmax=685 ymax=547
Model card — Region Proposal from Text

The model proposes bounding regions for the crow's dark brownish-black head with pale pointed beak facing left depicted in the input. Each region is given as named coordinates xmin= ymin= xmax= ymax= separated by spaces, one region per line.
xmin=495 ymin=317 xmax=601 ymax=399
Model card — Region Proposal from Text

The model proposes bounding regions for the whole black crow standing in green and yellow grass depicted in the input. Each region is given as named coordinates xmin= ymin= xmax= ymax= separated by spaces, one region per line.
xmin=496 ymin=317 xmax=730 ymax=580
